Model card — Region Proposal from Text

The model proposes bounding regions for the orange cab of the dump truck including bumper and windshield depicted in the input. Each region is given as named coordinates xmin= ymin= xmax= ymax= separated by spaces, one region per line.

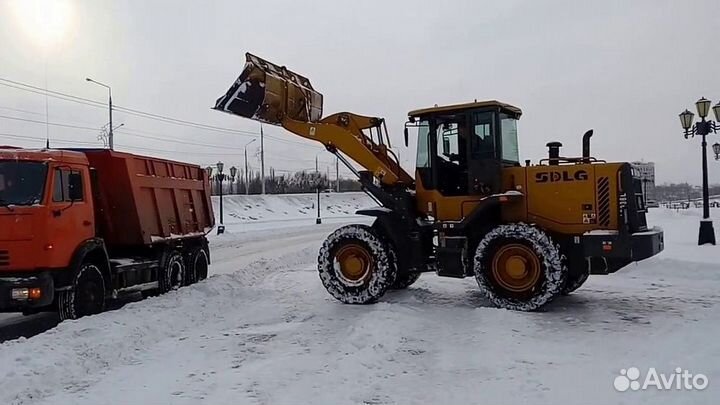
xmin=0 ymin=148 xmax=95 ymax=310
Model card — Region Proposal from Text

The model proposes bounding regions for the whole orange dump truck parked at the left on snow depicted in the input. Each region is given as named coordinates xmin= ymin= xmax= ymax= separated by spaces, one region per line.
xmin=0 ymin=146 xmax=214 ymax=319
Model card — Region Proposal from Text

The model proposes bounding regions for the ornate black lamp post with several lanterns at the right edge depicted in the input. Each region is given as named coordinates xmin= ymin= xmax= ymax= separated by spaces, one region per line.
xmin=680 ymin=97 xmax=720 ymax=245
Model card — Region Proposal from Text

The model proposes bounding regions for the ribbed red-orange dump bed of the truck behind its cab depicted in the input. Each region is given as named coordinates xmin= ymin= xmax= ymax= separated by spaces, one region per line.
xmin=83 ymin=149 xmax=215 ymax=247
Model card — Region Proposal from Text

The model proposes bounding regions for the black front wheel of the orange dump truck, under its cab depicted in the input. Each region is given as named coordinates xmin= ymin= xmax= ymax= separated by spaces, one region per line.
xmin=57 ymin=263 xmax=105 ymax=321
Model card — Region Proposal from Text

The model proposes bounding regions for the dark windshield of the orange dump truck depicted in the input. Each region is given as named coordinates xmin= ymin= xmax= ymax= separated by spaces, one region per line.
xmin=0 ymin=160 xmax=47 ymax=206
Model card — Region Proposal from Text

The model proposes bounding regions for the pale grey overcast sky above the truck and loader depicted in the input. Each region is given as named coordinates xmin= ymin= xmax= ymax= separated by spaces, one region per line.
xmin=0 ymin=0 xmax=720 ymax=184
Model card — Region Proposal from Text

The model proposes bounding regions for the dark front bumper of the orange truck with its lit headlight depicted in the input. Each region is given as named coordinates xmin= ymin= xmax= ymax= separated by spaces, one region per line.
xmin=0 ymin=272 xmax=55 ymax=312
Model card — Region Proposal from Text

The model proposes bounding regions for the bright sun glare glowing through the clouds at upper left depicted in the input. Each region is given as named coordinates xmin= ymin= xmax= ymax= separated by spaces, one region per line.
xmin=11 ymin=0 xmax=73 ymax=48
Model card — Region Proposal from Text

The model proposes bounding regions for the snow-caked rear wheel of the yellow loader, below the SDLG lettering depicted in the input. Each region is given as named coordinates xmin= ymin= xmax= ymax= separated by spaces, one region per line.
xmin=475 ymin=223 xmax=567 ymax=311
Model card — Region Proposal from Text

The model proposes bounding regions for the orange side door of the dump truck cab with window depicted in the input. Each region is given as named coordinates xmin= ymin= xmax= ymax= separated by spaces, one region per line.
xmin=48 ymin=166 xmax=95 ymax=267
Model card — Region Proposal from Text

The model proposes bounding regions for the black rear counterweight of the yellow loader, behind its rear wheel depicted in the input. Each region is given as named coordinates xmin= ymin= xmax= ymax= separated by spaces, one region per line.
xmin=576 ymin=228 xmax=665 ymax=274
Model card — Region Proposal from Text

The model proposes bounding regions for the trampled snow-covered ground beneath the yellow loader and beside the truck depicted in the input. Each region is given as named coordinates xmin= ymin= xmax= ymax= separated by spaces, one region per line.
xmin=0 ymin=205 xmax=720 ymax=404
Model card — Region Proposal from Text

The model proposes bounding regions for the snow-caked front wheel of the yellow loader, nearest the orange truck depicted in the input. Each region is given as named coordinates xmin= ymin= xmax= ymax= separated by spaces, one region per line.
xmin=318 ymin=225 xmax=397 ymax=304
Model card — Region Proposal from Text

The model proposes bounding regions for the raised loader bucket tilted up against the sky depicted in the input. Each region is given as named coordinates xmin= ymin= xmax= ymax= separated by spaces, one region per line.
xmin=214 ymin=53 xmax=322 ymax=125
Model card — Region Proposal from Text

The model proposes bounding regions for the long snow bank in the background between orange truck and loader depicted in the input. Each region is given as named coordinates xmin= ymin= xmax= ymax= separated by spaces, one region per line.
xmin=212 ymin=192 xmax=377 ymax=225
